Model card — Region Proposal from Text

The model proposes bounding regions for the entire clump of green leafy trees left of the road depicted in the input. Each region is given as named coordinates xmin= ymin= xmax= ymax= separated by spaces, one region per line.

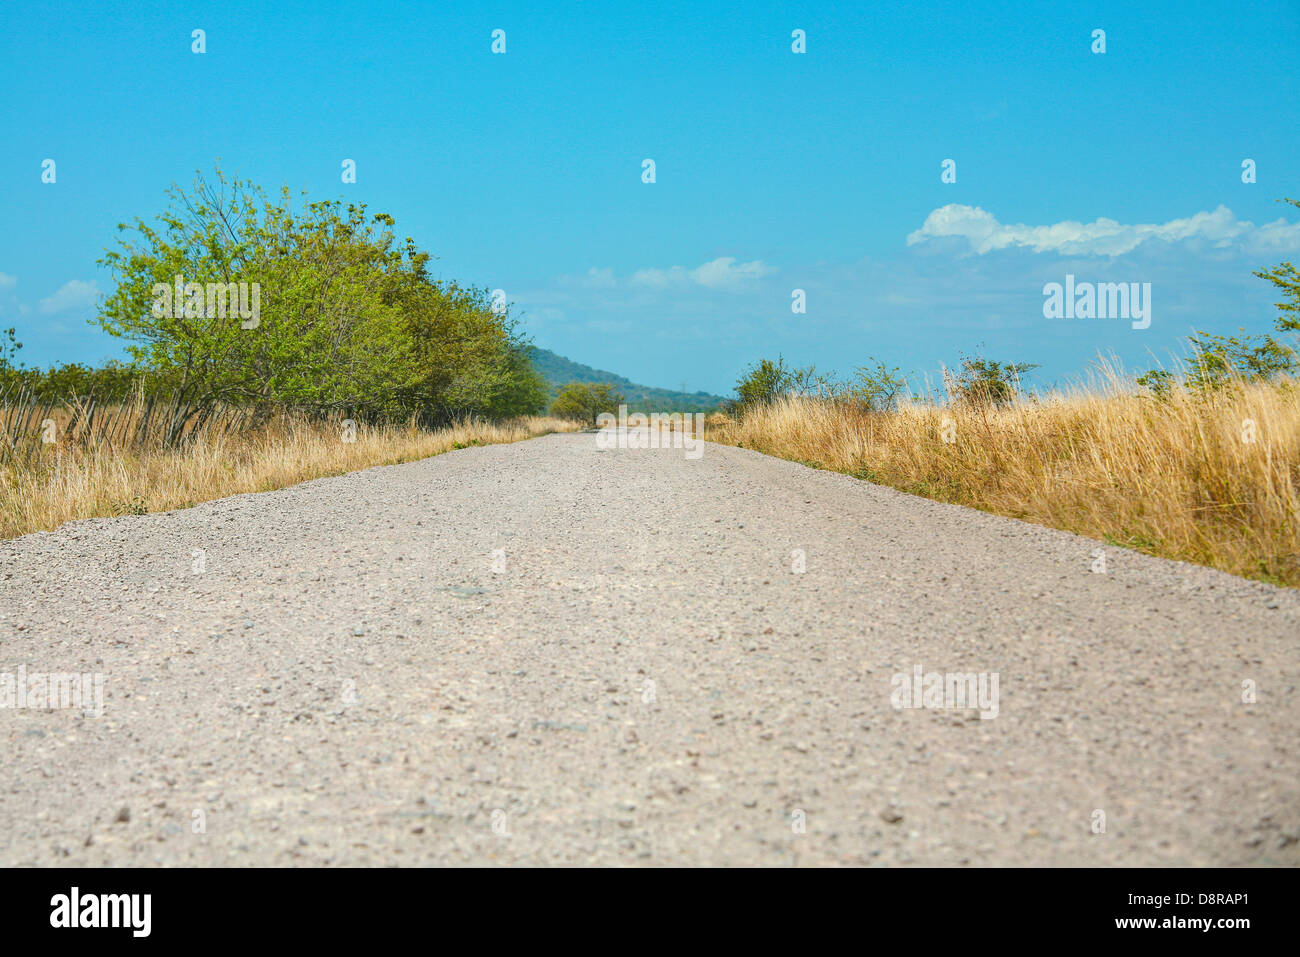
xmin=98 ymin=169 xmax=545 ymax=423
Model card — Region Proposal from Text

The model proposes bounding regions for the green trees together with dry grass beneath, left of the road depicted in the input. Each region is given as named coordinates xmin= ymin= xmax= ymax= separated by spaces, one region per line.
xmin=0 ymin=169 xmax=575 ymax=537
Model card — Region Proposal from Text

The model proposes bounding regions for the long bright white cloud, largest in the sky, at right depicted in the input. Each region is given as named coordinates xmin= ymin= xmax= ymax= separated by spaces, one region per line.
xmin=907 ymin=204 xmax=1300 ymax=256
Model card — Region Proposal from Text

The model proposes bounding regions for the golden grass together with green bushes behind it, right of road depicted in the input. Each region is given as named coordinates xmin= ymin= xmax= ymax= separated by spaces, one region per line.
xmin=707 ymin=208 xmax=1300 ymax=586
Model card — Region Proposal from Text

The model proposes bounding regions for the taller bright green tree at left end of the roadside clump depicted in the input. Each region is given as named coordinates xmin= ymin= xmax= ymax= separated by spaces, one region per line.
xmin=99 ymin=164 xmax=410 ymax=410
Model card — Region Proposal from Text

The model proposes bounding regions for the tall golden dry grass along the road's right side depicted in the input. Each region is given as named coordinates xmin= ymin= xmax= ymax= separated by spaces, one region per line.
xmin=707 ymin=377 xmax=1300 ymax=586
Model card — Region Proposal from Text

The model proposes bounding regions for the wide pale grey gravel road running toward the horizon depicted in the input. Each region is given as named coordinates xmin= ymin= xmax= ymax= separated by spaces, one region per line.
xmin=0 ymin=434 xmax=1300 ymax=866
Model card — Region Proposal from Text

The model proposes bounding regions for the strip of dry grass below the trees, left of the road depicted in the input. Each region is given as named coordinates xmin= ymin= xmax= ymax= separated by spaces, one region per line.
xmin=0 ymin=402 xmax=577 ymax=538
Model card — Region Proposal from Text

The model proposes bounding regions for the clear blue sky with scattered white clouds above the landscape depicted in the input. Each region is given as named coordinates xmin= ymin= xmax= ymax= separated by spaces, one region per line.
xmin=0 ymin=0 xmax=1300 ymax=393
